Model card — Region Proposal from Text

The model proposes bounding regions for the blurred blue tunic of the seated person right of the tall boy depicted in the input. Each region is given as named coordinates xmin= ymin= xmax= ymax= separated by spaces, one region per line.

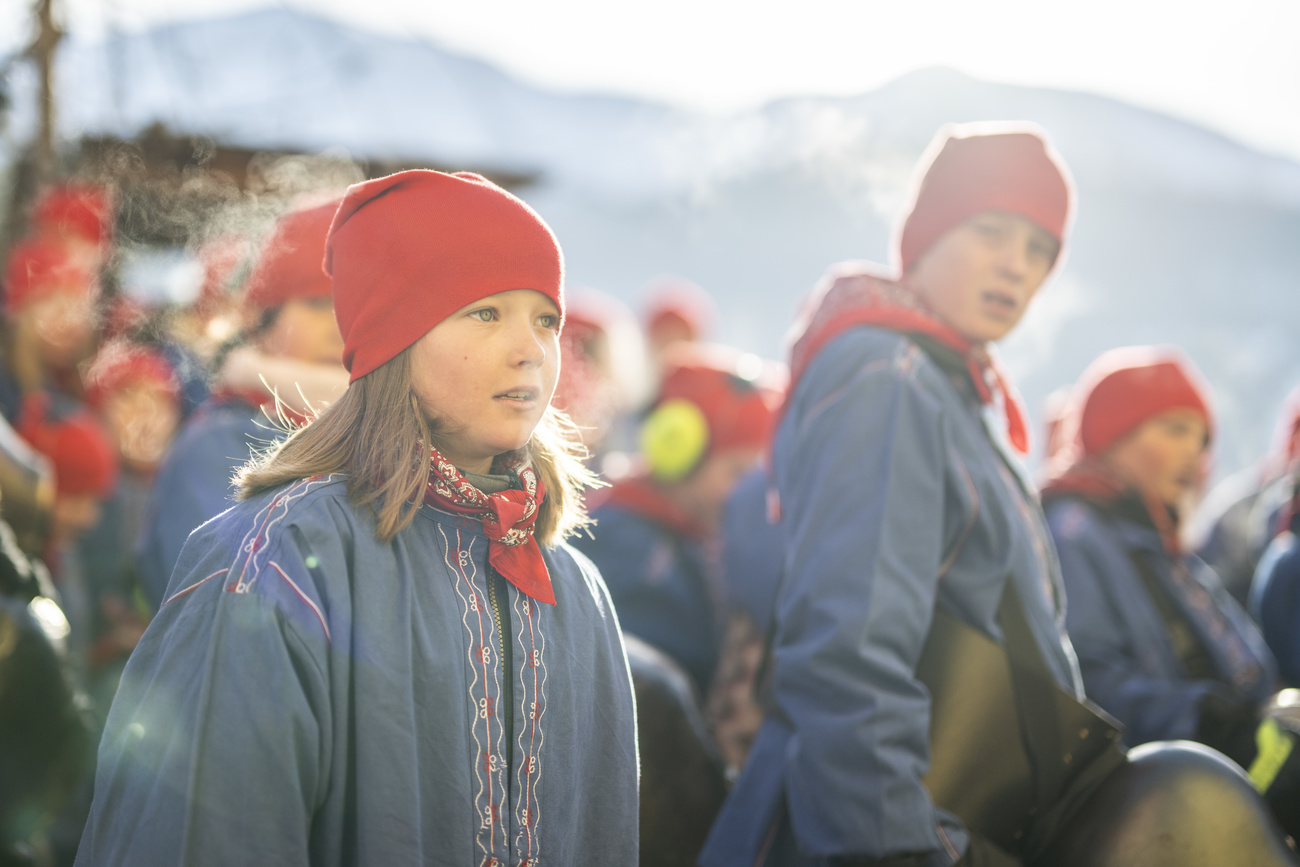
xmin=1048 ymin=497 xmax=1277 ymax=746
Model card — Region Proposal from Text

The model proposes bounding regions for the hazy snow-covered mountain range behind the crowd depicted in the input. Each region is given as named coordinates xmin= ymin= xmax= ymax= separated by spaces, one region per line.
xmin=10 ymin=9 xmax=1300 ymax=471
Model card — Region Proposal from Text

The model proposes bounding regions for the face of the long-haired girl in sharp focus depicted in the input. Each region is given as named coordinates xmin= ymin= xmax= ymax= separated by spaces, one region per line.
xmin=411 ymin=289 xmax=560 ymax=473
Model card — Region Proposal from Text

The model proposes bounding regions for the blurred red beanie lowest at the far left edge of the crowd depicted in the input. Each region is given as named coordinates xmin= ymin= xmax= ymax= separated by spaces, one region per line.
xmin=18 ymin=409 xmax=117 ymax=499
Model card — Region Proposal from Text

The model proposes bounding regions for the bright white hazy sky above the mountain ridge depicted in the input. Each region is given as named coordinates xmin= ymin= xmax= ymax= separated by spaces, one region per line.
xmin=0 ymin=0 xmax=1300 ymax=159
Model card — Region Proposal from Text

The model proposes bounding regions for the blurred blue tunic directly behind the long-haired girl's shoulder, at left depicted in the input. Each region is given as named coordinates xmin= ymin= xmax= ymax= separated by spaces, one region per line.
xmin=135 ymin=398 xmax=274 ymax=610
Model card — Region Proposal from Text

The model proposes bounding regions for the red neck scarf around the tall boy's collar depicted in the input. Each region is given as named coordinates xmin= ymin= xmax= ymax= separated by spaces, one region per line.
xmin=788 ymin=265 xmax=1030 ymax=456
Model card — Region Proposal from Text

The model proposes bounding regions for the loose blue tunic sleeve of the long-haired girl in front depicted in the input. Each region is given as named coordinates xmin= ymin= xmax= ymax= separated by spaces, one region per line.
xmin=77 ymin=523 xmax=330 ymax=867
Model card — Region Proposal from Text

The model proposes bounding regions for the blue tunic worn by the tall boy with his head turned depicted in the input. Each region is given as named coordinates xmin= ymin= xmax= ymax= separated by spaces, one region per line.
xmin=701 ymin=328 xmax=1082 ymax=867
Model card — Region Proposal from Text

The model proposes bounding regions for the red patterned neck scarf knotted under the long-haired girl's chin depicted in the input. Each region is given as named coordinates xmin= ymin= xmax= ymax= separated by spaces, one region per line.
xmin=424 ymin=448 xmax=555 ymax=604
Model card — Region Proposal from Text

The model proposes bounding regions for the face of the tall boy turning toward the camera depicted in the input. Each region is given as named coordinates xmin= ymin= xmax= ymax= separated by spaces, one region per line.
xmin=905 ymin=211 xmax=1061 ymax=343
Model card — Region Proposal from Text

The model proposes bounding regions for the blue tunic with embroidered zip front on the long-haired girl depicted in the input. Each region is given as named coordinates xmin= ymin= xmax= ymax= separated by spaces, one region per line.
xmin=77 ymin=477 xmax=637 ymax=867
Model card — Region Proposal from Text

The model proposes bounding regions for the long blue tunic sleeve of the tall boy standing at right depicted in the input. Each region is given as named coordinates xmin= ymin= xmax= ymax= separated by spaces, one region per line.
xmin=775 ymin=330 xmax=965 ymax=863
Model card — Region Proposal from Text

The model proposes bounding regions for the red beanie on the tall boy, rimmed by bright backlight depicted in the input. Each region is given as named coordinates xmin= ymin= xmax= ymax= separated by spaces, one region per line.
xmin=898 ymin=123 xmax=1074 ymax=273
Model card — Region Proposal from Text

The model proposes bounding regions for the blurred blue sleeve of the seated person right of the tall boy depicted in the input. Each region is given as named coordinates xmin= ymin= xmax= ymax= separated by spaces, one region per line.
xmin=1049 ymin=503 xmax=1217 ymax=746
